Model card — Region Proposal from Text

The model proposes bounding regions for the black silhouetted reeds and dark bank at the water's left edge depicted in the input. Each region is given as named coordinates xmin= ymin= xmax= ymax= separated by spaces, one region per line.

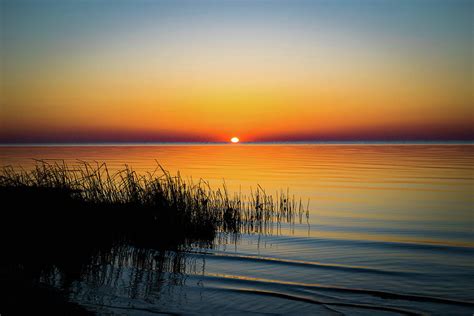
xmin=0 ymin=161 xmax=307 ymax=314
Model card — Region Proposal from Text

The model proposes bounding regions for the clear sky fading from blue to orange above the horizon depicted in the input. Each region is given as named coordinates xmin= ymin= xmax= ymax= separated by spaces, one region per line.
xmin=0 ymin=0 xmax=474 ymax=143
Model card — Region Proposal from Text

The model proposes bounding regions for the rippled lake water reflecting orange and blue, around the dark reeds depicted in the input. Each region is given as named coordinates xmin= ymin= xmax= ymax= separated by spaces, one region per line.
xmin=0 ymin=144 xmax=474 ymax=315
